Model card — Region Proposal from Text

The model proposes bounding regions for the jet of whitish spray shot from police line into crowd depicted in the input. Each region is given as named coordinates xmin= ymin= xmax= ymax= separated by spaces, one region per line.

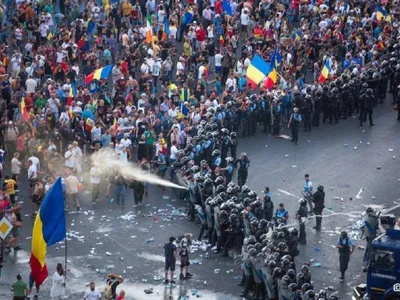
xmin=91 ymin=149 xmax=187 ymax=189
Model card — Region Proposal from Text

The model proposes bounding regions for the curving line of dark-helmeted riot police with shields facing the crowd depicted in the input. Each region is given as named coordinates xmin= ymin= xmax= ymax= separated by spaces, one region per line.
xmin=161 ymin=38 xmax=400 ymax=300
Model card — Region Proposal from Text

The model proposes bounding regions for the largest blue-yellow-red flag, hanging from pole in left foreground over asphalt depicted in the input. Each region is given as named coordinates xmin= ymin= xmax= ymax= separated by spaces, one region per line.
xmin=30 ymin=177 xmax=67 ymax=285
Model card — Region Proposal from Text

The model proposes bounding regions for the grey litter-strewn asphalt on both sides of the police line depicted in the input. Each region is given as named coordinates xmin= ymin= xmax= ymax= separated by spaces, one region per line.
xmin=0 ymin=97 xmax=400 ymax=300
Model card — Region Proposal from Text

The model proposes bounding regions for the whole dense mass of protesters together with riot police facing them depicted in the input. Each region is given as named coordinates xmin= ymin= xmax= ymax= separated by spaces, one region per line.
xmin=0 ymin=0 xmax=400 ymax=299
